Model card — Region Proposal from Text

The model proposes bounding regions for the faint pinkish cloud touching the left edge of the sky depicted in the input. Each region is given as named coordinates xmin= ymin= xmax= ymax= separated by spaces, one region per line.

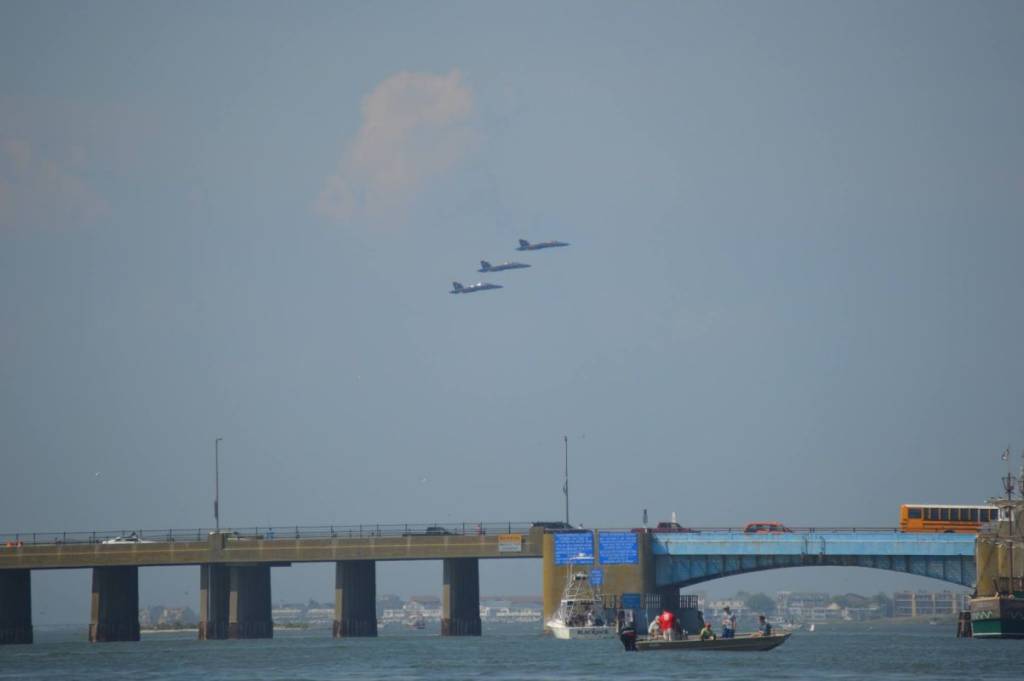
xmin=0 ymin=137 xmax=108 ymax=229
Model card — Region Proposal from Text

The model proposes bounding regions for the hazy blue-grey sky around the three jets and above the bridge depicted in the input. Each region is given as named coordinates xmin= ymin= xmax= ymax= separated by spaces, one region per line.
xmin=0 ymin=0 xmax=1024 ymax=624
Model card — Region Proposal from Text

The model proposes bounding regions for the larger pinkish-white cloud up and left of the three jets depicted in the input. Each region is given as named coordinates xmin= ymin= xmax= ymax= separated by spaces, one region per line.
xmin=315 ymin=70 xmax=476 ymax=220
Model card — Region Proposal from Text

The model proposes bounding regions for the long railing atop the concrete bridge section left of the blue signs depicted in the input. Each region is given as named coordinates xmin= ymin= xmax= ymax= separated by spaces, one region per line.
xmin=0 ymin=521 xmax=532 ymax=550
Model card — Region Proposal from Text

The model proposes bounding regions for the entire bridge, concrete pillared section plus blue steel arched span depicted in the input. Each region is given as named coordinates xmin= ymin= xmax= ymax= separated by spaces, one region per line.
xmin=0 ymin=522 xmax=978 ymax=644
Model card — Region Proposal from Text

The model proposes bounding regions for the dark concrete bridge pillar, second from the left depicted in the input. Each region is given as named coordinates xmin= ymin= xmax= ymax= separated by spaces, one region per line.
xmin=89 ymin=565 xmax=138 ymax=643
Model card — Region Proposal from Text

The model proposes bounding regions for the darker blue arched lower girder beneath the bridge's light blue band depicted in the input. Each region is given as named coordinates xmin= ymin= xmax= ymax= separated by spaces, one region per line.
xmin=654 ymin=554 xmax=977 ymax=588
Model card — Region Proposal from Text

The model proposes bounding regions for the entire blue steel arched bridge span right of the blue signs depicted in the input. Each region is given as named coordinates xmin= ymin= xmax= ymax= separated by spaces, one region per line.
xmin=650 ymin=529 xmax=977 ymax=588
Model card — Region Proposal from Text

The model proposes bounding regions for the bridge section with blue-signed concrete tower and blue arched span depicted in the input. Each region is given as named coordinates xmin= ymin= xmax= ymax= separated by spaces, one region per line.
xmin=543 ymin=527 xmax=978 ymax=634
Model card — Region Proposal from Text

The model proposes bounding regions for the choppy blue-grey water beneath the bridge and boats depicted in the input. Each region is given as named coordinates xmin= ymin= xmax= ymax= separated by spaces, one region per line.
xmin=0 ymin=623 xmax=1024 ymax=681
